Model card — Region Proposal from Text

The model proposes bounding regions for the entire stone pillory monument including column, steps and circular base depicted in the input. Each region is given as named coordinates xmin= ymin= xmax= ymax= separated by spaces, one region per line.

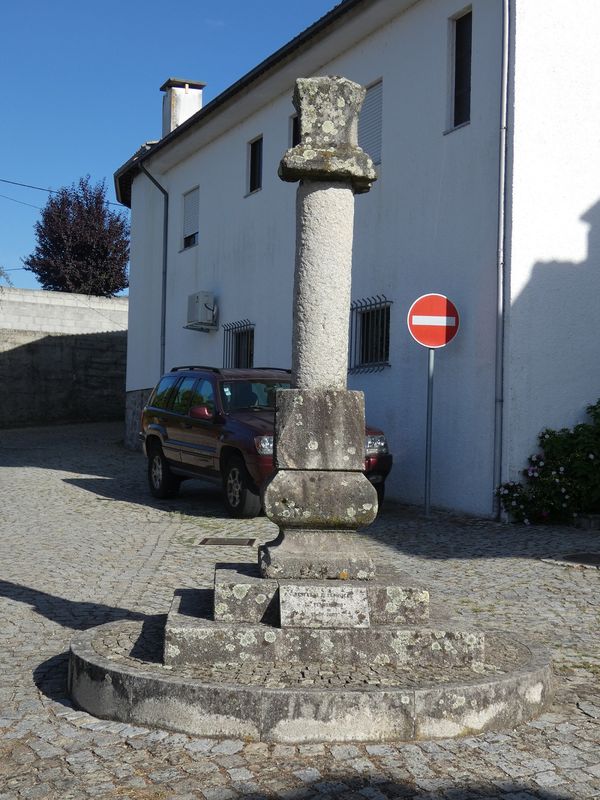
xmin=69 ymin=78 xmax=551 ymax=743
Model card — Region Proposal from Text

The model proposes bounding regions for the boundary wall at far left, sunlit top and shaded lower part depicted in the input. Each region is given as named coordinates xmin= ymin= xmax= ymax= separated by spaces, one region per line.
xmin=0 ymin=287 xmax=129 ymax=428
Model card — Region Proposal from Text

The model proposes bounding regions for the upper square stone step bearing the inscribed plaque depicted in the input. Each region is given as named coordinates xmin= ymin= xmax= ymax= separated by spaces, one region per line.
xmin=214 ymin=564 xmax=429 ymax=628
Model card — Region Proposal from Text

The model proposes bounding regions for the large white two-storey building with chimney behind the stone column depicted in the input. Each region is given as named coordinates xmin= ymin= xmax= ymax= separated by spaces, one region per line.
xmin=116 ymin=0 xmax=600 ymax=515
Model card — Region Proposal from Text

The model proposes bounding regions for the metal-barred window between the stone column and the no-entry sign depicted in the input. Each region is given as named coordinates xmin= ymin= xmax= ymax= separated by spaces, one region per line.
xmin=348 ymin=295 xmax=392 ymax=373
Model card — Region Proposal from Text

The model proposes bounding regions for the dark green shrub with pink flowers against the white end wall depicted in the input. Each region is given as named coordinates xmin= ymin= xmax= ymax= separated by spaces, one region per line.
xmin=496 ymin=400 xmax=600 ymax=525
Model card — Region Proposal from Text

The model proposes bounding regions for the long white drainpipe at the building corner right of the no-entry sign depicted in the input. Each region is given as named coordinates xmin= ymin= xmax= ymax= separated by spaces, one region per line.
xmin=494 ymin=0 xmax=510 ymax=519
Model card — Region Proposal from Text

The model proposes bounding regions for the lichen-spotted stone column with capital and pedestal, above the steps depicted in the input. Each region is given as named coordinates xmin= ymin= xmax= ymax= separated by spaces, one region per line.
xmin=259 ymin=77 xmax=377 ymax=580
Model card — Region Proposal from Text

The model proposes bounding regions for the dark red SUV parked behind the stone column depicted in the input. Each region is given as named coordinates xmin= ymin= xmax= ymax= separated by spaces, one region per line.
xmin=140 ymin=367 xmax=392 ymax=517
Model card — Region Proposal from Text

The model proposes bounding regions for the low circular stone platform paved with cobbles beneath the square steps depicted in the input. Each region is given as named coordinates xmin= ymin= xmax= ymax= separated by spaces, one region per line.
xmin=69 ymin=620 xmax=552 ymax=742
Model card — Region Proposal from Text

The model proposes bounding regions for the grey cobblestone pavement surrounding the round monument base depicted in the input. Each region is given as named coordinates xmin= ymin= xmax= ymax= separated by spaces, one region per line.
xmin=0 ymin=424 xmax=600 ymax=800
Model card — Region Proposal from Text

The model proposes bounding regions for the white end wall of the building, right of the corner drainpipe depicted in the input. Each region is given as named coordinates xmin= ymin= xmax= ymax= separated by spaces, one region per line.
xmin=504 ymin=0 xmax=600 ymax=479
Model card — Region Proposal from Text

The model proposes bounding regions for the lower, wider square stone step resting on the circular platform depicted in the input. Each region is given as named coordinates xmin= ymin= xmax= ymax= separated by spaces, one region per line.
xmin=164 ymin=590 xmax=484 ymax=666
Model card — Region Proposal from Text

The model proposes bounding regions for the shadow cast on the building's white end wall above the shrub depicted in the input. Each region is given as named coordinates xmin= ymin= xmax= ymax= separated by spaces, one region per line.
xmin=507 ymin=202 xmax=600 ymax=462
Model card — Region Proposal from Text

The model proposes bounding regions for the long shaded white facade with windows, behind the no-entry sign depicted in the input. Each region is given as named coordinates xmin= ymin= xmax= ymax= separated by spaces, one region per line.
xmin=127 ymin=0 xmax=501 ymax=514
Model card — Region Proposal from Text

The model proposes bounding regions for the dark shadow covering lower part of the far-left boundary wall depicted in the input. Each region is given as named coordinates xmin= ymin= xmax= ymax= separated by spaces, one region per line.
xmin=0 ymin=330 xmax=127 ymax=428
